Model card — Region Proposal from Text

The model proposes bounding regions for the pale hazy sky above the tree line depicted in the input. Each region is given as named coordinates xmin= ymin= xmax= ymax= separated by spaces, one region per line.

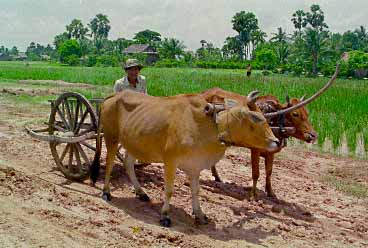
xmin=0 ymin=0 xmax=368 ymax=51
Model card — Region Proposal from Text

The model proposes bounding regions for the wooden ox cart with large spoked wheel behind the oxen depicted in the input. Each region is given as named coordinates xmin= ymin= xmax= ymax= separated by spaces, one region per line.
xmin=25 ymin=92 xmax=123 ymax=181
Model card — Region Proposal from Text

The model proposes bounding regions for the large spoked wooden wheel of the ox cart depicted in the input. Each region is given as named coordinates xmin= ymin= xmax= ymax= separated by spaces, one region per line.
xmin=49 ymin=92 xmax=97 ymax=181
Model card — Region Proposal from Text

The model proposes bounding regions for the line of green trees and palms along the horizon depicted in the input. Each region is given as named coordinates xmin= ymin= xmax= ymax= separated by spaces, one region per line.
xmin=0 ymin=4 xmax=368 ymax=77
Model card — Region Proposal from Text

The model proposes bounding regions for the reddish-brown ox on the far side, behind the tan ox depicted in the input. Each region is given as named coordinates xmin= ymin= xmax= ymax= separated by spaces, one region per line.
xmin=202 ymin=65 xmax=339 ymax=198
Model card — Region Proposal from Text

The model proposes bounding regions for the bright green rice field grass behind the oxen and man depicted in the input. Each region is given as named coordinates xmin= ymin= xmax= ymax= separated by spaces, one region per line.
xmin=0 ymin=62 xmax=368 ymax=155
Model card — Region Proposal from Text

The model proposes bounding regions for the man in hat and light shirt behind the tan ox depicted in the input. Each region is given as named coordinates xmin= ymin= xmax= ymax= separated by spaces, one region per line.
xmin=114 ymin=59 xmax=147 ymax=94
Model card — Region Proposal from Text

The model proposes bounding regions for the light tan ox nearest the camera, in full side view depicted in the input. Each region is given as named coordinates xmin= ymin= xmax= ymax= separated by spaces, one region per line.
xmin=91 ymin=90 xmax=279 ymax=226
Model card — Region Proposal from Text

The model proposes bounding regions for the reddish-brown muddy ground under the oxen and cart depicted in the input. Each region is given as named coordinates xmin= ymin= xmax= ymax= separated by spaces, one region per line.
xmin=0 ymin=81 xmax=368 ymax=247
